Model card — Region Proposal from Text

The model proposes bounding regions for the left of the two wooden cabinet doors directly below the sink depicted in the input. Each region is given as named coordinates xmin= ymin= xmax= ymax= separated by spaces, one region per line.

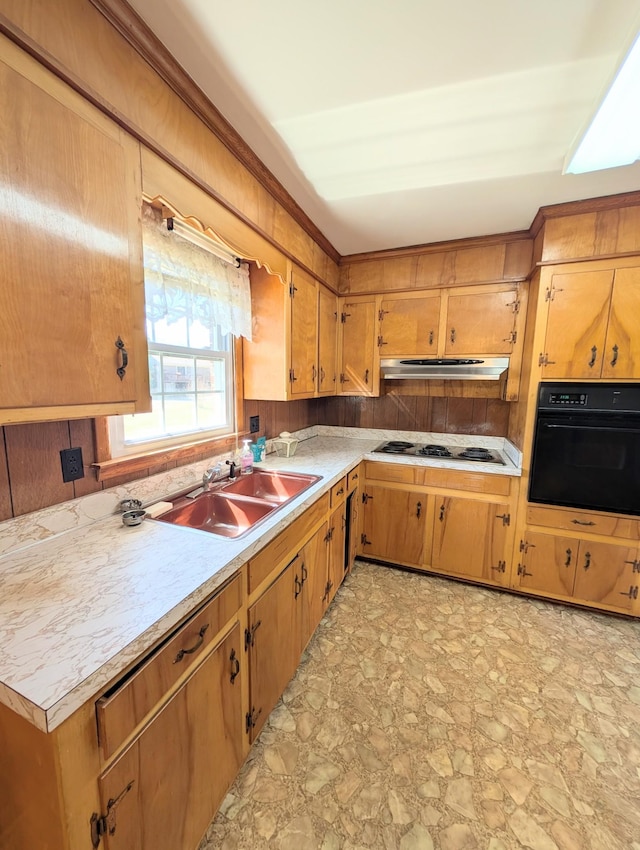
xmin=249 ymin=555 xmax=303 ymax=741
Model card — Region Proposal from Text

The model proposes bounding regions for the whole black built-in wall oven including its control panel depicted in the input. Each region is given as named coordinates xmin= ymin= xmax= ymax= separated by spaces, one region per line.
xmin=529 ymin=383 xmax=640 ymax=516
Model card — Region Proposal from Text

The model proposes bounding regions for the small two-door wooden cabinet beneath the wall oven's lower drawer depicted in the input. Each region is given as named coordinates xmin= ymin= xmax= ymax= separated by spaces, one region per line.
xmin=514 ymin=531 xmax=640 ymax=614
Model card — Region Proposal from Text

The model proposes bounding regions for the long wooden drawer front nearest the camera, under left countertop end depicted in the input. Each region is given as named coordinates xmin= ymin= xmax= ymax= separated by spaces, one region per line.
xmin=96 ymin=576 xmax=242 ymax=758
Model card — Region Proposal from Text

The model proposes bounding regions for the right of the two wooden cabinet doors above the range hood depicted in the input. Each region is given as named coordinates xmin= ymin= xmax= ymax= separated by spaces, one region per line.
xmin=444 ymin=290 xmax=518 ymax=356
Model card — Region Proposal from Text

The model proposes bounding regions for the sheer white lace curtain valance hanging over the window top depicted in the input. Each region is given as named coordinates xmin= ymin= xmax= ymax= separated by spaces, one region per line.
xmin=142 ymin=206 xmax=251 ymax=340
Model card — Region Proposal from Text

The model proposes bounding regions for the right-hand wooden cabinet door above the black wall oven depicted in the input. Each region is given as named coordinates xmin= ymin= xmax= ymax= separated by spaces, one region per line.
xmin=602 ymin=268 xmax=640 ymax=379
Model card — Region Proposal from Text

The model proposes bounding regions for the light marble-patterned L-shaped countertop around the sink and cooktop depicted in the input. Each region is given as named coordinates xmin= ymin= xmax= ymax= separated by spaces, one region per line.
xmin=0 ymin=426 xmax=520 ymax=731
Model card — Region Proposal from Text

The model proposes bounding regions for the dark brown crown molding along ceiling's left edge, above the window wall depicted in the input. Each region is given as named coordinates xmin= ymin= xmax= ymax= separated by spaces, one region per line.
xmin=90 ymin=0 xmax=340 ymax=263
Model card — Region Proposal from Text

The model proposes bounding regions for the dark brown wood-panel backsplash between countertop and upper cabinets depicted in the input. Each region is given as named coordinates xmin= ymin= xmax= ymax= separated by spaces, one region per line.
xmin=0 ymin=396 xmax=509 ymax=520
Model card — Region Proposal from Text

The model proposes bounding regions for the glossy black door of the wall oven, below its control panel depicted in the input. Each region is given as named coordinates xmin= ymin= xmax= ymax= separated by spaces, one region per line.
xmin=529 ymin=411 xmax=640 ymax=516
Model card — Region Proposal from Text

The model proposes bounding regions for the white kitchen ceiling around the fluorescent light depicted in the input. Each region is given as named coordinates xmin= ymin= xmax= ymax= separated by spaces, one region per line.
xmin=128 ymin=0 xmax=640 ymax=255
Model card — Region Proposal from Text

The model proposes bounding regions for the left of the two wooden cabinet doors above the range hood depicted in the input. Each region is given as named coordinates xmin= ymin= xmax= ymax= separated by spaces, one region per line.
xmin=378 ymin=295 xmax=440 ymax=357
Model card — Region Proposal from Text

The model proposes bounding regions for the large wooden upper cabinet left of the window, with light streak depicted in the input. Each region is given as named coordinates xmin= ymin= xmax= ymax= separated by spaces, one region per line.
xmin=0 ymin=41 xmax=150 ymax=424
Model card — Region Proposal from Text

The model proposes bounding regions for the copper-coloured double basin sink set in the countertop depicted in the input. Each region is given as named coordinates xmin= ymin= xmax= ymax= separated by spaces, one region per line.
xmin=157 ymin=469 xmax=321 ymax=537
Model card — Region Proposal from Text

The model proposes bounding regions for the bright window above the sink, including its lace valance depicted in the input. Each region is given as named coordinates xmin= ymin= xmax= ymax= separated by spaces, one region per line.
xmin=110 ymin=207 xmax=251 ymax=457
